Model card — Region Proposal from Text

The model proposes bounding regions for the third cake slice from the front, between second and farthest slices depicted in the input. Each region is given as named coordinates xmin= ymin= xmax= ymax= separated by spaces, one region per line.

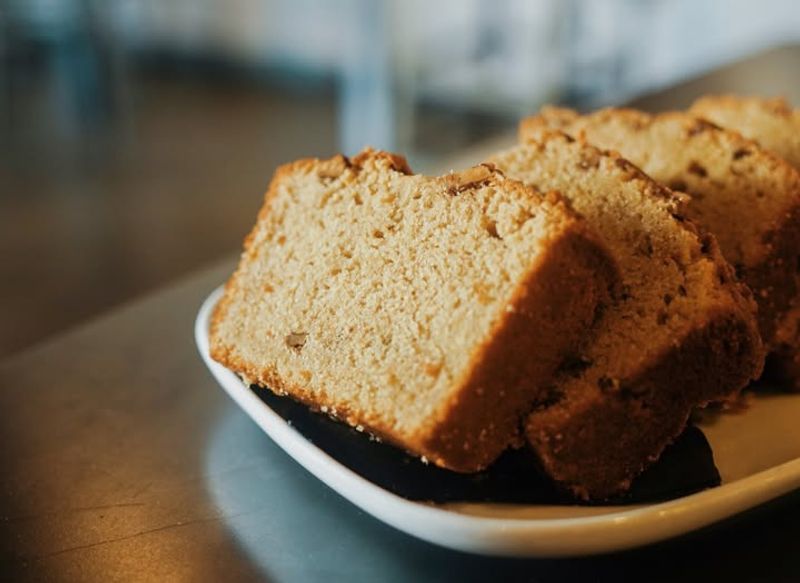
xmin=520 ymin=107 xmax=800 ymax=388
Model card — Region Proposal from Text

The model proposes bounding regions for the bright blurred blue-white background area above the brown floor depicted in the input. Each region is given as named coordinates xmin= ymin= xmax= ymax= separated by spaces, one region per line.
xmin=6 ymin=0 xmax=800 ymax=152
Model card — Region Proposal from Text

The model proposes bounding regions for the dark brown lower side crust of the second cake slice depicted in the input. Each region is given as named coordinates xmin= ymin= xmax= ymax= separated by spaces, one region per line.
xmin=526 ymin=304 xmax=760 ymax=500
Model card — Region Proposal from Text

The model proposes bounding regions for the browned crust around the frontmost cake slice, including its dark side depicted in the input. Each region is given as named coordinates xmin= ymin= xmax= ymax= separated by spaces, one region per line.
xmin=210 ymin=150 xmax=617 ymax=471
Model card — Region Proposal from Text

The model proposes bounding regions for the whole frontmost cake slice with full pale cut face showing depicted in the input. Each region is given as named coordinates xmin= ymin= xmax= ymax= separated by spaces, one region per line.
xmin=211 ymin=150 xmax=617 ymax=472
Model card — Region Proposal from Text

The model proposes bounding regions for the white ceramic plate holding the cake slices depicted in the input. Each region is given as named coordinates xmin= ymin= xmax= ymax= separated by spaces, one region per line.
xmin=195 ymin=288 xmax=800 ymax=557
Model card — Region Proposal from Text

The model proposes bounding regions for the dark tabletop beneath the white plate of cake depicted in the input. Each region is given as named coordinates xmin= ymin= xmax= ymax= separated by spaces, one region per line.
xmin=0 ymin=47 xmax=800 ymax=581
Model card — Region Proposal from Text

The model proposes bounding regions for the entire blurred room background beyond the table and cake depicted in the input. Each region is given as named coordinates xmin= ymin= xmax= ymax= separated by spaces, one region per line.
xmin=0 ymin=0 xmax=800 ymax=356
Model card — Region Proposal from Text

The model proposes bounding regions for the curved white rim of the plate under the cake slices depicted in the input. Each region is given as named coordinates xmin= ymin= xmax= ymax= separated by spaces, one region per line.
xmin=194 ymin=285 xmax=800 ymax=558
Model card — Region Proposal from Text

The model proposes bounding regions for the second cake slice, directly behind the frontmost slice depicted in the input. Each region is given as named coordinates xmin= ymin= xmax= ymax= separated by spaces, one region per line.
xmin=489 ymin=131 xmax=763 ymax=499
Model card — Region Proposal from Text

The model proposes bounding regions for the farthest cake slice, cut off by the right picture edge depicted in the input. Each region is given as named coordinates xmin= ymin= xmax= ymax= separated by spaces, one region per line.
xmin=689 ymin=95 xmax=800 ymax=391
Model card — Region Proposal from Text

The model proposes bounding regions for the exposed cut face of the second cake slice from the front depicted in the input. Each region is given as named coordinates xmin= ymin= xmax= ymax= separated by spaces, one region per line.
xmin=489 ymin=130 xmax=763 ymax=398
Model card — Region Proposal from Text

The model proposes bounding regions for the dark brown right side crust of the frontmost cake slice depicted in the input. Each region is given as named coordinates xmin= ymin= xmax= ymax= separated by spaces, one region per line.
xmin=419 ymin=222 xmax=619 ymax=472
